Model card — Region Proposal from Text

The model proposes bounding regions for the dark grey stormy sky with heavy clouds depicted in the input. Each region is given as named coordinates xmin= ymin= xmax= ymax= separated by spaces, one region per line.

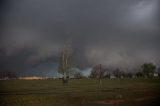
xmin=0 ymin=0 xmax=160 ymax=76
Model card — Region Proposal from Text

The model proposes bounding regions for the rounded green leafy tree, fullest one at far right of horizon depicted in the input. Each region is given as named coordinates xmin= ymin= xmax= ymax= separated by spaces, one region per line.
xmin=141 ymin=63 xmax=156 ymax=76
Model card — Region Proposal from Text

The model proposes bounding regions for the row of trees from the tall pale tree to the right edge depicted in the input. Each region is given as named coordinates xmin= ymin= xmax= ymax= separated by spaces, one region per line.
xmin=58 ymin=43 xmax=160 ymax=83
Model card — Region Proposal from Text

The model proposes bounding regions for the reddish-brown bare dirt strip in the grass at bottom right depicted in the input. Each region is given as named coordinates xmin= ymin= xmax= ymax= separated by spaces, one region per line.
xmin=96 ymin=95 xmax=160 ymax=105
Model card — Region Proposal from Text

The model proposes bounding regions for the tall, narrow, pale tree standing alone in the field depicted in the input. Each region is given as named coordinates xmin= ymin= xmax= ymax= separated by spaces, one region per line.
xmin=58 ymin=43 xmax=72 ymax=83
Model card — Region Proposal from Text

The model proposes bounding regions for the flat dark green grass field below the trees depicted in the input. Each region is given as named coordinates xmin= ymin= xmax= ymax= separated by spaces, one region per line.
xmin=0 ymin=78 xmax=160 ymax=106
